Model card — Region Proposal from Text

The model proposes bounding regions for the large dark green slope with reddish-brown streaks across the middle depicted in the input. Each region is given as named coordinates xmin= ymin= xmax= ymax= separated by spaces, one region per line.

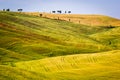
xmin=0 ymin=12 xmax=114 ymax=64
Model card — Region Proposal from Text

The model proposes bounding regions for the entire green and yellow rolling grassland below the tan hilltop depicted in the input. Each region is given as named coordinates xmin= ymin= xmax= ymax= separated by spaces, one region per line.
xmin=0 ymin=12 xmax=120 ymax=80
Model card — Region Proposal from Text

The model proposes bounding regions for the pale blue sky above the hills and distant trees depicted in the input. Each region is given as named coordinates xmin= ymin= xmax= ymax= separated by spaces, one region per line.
xmin=0 ymin=0 xmax=120 ymax=19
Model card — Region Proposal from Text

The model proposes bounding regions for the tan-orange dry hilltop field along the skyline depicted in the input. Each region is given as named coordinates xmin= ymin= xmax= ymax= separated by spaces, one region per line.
xmin=25 ymin=12 xmax=120 ymax=26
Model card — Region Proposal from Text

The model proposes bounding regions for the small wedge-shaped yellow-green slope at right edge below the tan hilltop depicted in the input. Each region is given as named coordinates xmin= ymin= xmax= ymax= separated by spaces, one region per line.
xmin=90 ymin=27 xmax=120 ymax=49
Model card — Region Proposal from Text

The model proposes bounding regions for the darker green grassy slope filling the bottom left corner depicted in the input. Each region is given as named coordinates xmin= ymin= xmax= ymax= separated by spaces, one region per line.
xmin=0 ymin=65 xmax=49 ymax=80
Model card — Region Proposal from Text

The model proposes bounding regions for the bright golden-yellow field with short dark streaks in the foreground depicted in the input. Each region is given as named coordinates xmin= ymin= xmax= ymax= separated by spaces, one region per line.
xmin=15 ymin=50 xmax=120 ymax=80
